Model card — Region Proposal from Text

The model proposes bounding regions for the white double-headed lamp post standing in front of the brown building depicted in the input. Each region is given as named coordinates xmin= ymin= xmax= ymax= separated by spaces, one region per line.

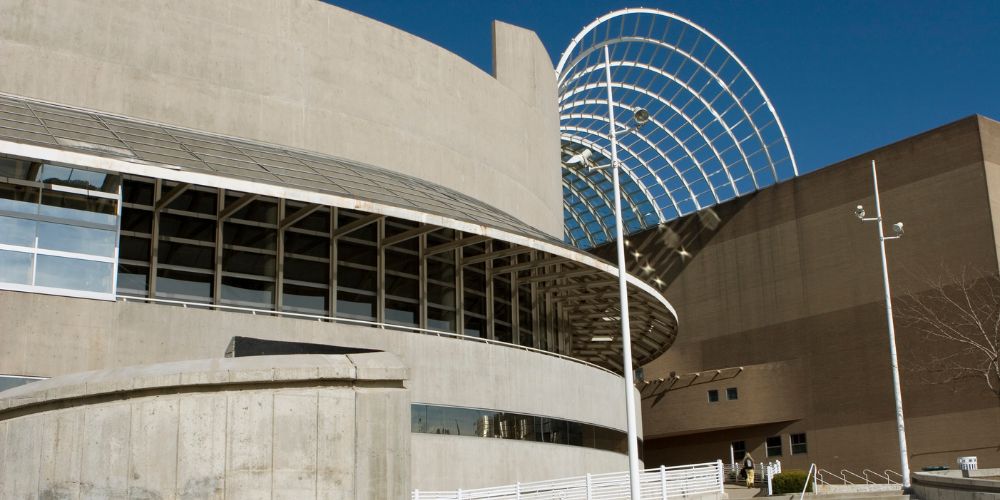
xmin=854 ymin=160 xmax=910 ymax=490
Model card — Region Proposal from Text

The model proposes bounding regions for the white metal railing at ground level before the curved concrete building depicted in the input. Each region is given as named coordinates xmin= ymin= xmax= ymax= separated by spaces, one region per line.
xmin=412 ymin=460 xmax=724 ymax=500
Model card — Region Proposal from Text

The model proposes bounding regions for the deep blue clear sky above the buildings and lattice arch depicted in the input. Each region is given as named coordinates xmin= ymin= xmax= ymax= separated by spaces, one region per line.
xmin=331 ymin=0 xmax=1000 ymax=172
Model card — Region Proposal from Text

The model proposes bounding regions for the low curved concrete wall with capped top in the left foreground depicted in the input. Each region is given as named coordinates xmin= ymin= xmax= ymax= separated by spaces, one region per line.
xmin=0 ymin=353 xmax=410 ymax=499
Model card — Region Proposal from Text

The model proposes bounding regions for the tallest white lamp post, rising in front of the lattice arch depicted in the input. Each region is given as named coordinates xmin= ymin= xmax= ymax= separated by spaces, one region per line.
xmin=604 ymin=45 xmax=641 ymax=500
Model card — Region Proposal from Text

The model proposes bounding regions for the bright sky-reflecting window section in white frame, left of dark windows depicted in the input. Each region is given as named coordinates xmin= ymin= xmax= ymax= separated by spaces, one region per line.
xmin=0 ymin=157 xmax=120 ymax=299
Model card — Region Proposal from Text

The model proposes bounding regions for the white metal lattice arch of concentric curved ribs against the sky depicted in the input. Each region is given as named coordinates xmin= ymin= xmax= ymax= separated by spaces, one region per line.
xmin=556 ymin=8 xmax=798 ymax=248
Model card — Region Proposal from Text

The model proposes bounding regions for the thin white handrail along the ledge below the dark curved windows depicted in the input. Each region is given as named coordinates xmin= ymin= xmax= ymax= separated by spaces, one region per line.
xmin=115 ymin=295 xmax=621 ymax=377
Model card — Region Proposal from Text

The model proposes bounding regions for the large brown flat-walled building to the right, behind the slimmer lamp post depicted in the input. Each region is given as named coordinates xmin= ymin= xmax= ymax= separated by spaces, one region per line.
xmin=630 ymin=116 xmax=1000 ymax=472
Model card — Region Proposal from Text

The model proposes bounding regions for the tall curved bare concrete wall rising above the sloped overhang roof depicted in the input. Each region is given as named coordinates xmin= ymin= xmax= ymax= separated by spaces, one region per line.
xmin=0 ymin=0 xmax=562 ymax=238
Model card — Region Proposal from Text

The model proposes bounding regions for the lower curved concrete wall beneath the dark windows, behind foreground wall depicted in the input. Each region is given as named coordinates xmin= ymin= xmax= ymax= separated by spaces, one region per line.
xmin=0 ymin=292 xmax=641 ymax=489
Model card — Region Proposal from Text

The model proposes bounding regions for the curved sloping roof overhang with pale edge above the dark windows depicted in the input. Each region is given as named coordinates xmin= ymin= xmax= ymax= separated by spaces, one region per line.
xmin=0 ymin=96 xmax=677 ymax=371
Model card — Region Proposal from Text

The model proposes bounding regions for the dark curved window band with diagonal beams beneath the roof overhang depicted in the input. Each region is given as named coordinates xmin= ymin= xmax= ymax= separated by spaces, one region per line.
xmin=110 ymin=176 xmax=568 ymax=352
